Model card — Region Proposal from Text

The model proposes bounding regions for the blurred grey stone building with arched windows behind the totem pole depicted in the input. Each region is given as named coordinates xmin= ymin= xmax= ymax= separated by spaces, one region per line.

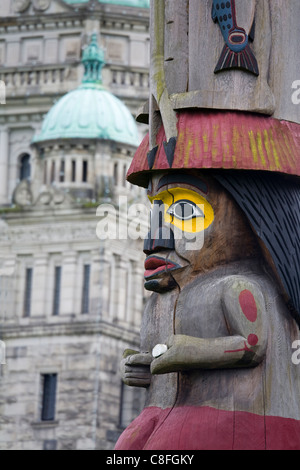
xmin=0 ymin=0 xmax=149 ymax=450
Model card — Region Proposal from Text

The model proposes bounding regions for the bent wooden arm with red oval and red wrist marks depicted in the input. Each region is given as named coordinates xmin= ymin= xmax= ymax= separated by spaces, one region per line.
xmin=151 ymin=278 xmax=268 ymax=374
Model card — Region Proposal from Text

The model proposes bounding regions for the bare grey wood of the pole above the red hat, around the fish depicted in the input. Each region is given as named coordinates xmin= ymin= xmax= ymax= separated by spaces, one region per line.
xmin=141 ymin=0 xmax=300 ymax=126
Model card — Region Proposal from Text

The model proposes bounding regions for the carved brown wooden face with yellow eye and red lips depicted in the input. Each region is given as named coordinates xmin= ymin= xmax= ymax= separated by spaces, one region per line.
xmin=144 ymin=172 xmax=256 ymax=292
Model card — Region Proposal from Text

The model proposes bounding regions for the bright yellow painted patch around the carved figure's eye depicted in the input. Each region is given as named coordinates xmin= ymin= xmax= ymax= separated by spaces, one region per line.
xmin=149 ymin=188 xmax=214 ymax=233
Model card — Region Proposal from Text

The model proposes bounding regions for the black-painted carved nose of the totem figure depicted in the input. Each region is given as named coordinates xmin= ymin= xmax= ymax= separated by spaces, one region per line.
xmin=144 ymin=201 xmax=175 ymax=255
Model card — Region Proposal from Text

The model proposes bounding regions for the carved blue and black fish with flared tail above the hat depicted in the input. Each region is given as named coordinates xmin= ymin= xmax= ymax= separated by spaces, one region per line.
xmin=212 ymin=0 xmax=259 ymax=75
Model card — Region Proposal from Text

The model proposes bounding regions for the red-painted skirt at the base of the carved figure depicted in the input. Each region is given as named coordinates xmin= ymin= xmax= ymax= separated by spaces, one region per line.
xmin=117 ymin=406 xmax=300 ymax=451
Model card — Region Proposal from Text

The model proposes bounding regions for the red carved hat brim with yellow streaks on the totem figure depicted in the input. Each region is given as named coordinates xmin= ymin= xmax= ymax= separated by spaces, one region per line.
xmin=127 ymin=110 xmax=300 ymax=187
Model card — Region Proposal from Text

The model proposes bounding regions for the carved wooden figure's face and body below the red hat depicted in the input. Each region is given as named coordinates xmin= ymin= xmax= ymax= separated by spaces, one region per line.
xmin=116 ymin=172 xmax=300 ymax=450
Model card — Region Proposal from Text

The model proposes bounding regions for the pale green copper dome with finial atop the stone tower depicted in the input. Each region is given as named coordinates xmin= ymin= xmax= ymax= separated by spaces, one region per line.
xmin=33 ymin=34 xmax=139 ymax=146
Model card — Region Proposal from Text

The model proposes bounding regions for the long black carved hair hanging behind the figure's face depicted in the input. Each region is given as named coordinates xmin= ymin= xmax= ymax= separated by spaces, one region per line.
xmin=217 ymin=172 xmax=300 ymax=324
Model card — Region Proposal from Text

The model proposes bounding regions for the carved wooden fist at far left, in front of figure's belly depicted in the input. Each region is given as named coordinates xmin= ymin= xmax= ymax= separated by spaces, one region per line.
xmin=120 ymin=349 xmax=153 ymax=387
